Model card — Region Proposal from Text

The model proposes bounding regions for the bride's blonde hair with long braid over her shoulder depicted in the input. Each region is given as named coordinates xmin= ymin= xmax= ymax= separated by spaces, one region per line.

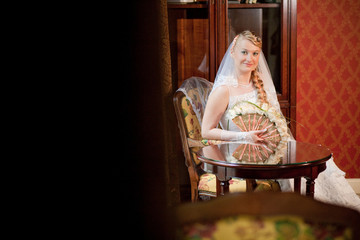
xmin=231 ymin=30 xmax=269 ymax=104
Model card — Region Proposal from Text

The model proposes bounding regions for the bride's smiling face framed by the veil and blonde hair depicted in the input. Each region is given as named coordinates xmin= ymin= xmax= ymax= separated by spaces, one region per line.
xmin=233 ymin=37 xmax=261 ymax=73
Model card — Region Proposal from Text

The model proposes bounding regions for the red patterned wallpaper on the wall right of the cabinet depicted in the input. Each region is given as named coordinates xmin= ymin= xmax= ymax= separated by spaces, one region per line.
xmin=296 ymin=0 xmax=360 ymax=178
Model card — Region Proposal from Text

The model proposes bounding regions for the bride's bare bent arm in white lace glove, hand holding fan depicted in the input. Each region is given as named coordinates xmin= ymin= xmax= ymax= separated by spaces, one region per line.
xmin=201 ymin=86 xmax=266 ymax=141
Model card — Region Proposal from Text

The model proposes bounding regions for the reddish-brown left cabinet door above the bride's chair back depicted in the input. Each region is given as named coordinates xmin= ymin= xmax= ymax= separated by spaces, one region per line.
xmin=168 ymin=1 xmax=215 ymax=87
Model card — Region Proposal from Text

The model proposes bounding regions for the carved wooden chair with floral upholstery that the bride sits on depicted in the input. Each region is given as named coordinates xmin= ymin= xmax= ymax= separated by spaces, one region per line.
xmin=173 ymin=77 xmax=276 ymax=202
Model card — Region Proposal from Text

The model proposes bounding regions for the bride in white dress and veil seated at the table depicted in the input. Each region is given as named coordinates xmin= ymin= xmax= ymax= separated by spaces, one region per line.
xmin=201 ymin=31 xmax=360 ymax=211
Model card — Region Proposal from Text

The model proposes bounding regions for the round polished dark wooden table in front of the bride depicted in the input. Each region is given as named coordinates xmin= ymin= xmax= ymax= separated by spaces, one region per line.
xmin=196 ymin=141 xmax=332 ymax=197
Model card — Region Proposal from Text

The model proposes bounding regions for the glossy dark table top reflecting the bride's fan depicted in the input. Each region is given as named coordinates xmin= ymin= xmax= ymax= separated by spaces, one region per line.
xmin=196 ymin=141 xmax=332 ymax=168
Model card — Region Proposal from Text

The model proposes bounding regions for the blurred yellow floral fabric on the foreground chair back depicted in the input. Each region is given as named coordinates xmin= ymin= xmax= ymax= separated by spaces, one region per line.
xmin=182 ymin=216 xmax=352 ymax=240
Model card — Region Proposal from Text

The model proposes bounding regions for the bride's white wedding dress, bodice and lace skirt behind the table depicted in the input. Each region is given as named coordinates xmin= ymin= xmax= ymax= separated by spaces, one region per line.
xmin=220 ymin=90 xmax=360 ymax=212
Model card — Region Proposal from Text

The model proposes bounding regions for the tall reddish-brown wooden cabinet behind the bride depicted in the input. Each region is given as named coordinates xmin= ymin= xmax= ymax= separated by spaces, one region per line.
xmin=168 ymin=0 xmax=296 ymax=136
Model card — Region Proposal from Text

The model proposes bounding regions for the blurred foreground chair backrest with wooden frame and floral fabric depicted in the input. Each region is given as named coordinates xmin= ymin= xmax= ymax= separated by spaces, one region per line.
xmin=177 ymin=192 xmax=360 ymax=239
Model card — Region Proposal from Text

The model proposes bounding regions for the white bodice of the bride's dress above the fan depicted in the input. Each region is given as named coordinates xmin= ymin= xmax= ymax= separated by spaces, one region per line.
xmin=220 ymin=89 xmax=258 ymax=131
